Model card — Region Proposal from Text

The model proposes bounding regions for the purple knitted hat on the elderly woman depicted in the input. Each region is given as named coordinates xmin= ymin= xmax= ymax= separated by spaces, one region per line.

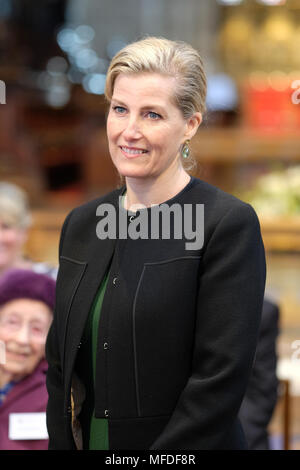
xmin=0 ymin=269 xmax=56 ymax=311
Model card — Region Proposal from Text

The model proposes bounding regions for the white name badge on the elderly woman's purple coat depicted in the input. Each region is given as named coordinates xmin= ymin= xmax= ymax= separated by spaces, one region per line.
xmin=8 ymin=413 xmax=48 ymax=441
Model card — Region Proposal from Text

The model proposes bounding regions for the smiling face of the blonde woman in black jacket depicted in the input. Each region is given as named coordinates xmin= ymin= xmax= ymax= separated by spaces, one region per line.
xmin=107 ymin=73 xmax=201 ymax=178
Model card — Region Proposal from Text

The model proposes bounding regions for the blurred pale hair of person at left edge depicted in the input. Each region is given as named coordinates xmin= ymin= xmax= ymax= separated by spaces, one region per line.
xmin=0 ymin=182 xmax=31 ymax=229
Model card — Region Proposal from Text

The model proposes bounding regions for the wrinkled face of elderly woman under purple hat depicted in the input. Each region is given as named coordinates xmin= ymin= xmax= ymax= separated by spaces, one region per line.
xmin=0 ymin=299 xmax=52 ymax=380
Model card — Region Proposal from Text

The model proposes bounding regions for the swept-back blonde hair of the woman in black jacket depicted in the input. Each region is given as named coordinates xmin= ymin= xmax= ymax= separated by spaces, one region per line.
xmin=105 ymin=37 xmax=207 ymax=119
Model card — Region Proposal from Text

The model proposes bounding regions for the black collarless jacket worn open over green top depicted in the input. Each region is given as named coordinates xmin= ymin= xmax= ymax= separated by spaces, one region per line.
xmin=46 ymin=178 xmax=265 ymax=449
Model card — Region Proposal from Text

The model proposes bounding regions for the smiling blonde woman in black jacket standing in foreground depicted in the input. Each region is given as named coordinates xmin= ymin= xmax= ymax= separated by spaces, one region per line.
xmin=46 ymin=38 xmax=265 ymax=450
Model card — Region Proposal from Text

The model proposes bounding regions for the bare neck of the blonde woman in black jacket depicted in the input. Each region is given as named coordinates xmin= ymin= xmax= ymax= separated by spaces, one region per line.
xmin=124 ymin=167 xmax=190 ymax=210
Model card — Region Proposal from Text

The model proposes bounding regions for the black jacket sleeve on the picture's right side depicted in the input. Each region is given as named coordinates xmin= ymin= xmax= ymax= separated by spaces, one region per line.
xmin=151 ymin=204 xmax=266 ymax=450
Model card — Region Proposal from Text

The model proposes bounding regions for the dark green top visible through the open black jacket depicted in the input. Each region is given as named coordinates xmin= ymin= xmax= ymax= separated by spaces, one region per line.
xmin=77 ymin=274 xmax=109 ymax=450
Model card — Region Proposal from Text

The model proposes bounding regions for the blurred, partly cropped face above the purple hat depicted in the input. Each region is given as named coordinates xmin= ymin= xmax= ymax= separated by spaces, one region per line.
xmin=0 ymin=218 xmax=26 ymax=271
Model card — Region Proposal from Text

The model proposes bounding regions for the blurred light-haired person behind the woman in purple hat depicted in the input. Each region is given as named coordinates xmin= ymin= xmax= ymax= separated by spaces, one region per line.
xmin=0 ymin=182 xmax=57 ymax=279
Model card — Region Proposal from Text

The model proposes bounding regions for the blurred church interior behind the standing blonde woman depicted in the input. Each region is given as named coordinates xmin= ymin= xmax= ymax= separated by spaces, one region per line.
xmin=0 ymin=0 xmax=300 ymax=449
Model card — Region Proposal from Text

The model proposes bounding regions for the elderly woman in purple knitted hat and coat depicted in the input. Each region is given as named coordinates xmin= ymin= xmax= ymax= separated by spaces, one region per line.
xmin=0 ymin=269 xmax=55 ymax=450
